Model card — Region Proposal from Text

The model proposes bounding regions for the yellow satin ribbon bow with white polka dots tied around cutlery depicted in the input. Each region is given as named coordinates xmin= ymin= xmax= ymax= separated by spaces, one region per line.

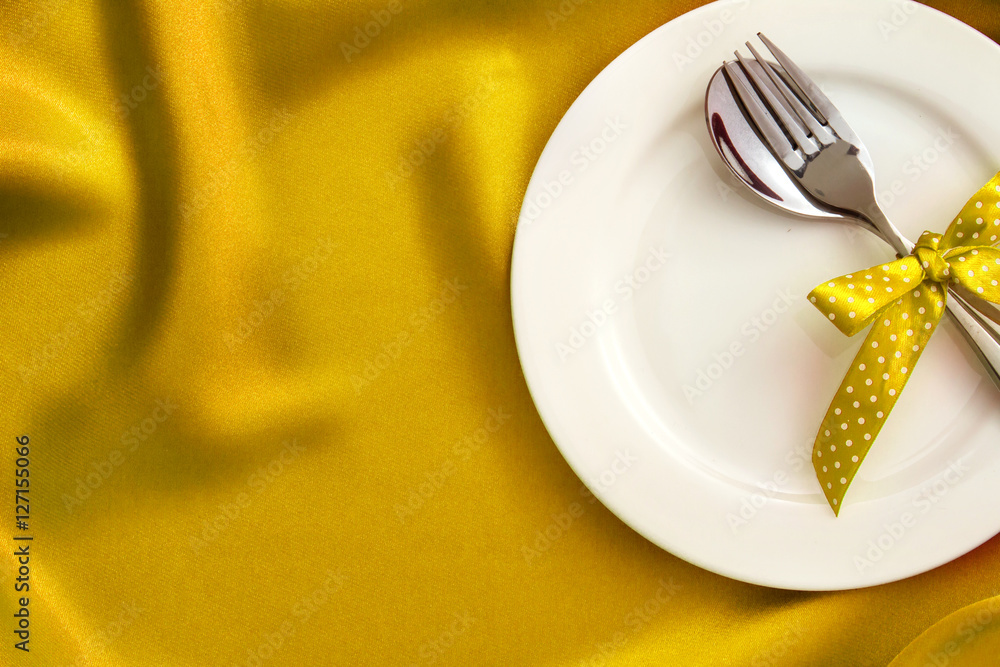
xmin=809 ymin=174 xmax=1000 ymax=515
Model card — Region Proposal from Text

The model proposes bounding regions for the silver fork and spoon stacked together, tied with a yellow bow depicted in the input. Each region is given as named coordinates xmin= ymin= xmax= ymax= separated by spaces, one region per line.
xmin=706 ymin=35 xmax=1000 ymax=387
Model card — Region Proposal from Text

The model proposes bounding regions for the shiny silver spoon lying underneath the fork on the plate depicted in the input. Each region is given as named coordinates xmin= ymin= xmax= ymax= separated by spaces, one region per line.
xmin=705 ymin=63 xmax=1000 ymax=387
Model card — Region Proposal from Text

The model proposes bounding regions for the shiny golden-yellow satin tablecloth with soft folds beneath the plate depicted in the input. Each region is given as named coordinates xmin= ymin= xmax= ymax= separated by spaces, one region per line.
xmin=0 ymin=0 xmax=1000 ymax=667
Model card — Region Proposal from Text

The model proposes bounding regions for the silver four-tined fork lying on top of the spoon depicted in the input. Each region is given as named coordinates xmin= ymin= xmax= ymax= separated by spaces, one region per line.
xmin=725 ymin=33 xmax=1000 ymax=387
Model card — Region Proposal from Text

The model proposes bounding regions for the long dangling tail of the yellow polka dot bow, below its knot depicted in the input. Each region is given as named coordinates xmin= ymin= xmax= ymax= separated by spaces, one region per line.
xmin=813 ymin=281 xmax=947 ymax=516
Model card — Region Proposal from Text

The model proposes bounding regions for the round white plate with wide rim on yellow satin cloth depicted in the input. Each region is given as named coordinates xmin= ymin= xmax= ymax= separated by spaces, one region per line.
xmin=512 ymin=0 xmax=1000 ymax=590
